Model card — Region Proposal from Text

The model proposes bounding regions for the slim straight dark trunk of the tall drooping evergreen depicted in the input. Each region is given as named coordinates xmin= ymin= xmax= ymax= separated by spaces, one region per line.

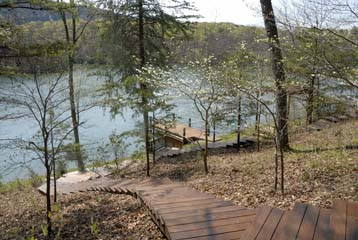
xmin=138 ymin=0 xmax=150 ymax=177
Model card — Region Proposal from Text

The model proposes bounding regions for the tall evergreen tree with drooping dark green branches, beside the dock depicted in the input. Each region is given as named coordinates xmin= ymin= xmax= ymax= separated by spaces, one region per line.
xmin=98 ymin=0 xmax=196 ymax=176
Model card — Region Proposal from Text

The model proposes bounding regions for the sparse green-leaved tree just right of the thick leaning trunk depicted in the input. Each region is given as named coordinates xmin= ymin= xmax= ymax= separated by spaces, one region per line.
xmin=279 ymin=1 xmax=342 ymax=125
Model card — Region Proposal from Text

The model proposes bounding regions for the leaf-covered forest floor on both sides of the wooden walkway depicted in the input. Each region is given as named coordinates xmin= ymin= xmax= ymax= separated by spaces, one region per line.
xmin=0 ymin=120 xmax=358 ymax=239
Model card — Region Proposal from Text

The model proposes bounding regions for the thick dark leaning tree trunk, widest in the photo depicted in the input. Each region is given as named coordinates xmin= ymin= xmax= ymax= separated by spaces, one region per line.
xmin=260 ymin=0 xmax=289 ymax=149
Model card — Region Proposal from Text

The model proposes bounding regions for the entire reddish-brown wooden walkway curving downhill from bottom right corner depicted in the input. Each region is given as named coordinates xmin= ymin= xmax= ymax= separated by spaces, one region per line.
xmin=39 ymin=178 xmax=358 ymax=240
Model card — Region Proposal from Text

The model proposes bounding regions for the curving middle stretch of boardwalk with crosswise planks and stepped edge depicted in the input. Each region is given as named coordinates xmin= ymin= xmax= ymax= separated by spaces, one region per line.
xmin=88 ymin=179 xmax=256 ymax=240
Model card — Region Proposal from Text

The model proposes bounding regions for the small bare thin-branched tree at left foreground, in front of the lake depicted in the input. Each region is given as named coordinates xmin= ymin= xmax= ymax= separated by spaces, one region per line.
xmin=0 ymin=72 xmax=79 ymax=239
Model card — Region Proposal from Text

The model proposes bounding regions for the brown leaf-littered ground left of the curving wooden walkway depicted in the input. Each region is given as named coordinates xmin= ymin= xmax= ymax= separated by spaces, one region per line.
xmin=0 ymin=188 xmax=164 ymax=240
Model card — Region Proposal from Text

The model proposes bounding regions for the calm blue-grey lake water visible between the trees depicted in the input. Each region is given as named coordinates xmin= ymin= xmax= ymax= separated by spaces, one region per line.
xmin=0 ymin=68 xmax=314 ymax=181
